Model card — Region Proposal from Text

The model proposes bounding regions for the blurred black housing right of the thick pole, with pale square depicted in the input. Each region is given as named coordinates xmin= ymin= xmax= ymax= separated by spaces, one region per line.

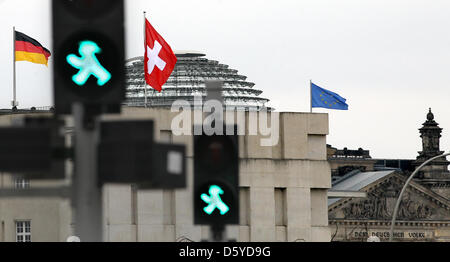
xmin=97 ymin=120 xmax=186 ymax=189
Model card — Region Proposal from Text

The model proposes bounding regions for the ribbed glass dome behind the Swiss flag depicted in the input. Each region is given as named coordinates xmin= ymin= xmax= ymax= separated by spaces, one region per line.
xmin=125 ymin=51 xmax=273 ymax=111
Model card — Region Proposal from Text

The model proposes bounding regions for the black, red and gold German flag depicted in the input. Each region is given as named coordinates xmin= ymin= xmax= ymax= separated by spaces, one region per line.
xmin=15 ymin=31 xmax=51 ymax=66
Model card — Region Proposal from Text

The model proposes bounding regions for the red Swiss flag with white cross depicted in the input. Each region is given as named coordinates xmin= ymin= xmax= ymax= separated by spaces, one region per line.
xmin=144 ymin=19 xmax=177 ymax=92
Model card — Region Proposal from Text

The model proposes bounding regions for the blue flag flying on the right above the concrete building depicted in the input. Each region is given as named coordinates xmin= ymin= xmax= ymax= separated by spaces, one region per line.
xmin=311 ymin=83 xmax=348 ymax=110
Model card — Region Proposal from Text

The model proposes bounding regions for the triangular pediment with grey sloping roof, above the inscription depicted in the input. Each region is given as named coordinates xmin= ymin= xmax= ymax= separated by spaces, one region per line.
xmin=328 ymin=171 xmax=450 ymax=221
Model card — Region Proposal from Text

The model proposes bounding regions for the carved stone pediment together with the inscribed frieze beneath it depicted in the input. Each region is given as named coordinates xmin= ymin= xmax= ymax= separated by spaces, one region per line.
xmin=328 ymin=171 xmax=450 ymax=241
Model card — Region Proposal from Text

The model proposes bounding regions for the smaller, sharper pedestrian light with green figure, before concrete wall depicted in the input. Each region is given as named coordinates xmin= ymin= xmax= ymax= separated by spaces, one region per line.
xmin=194 ymin=127 xmax=239 ymax=225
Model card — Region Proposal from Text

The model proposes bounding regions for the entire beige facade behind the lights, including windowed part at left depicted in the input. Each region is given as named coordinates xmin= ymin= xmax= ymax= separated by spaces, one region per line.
xmin=0 ymin=108 xmax=331 ymax=242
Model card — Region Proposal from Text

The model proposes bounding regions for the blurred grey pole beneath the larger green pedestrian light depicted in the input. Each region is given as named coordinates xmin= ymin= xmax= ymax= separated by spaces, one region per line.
xmin=73 ymin=104 xmax=103 ymax=242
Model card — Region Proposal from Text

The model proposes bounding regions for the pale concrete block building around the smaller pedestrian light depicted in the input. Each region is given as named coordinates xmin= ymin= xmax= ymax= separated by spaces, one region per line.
xmin=105 ymin=108 xmax=331 ymax=241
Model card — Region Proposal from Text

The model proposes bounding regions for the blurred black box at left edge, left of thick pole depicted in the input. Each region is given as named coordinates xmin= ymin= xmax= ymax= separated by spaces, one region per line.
xmin=0 ymin=117 xmax=67 ymax=180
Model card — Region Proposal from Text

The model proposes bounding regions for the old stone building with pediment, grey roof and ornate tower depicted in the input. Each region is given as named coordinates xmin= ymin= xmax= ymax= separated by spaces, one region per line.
xmin=328 ymin=109 xmax=450 ymax=242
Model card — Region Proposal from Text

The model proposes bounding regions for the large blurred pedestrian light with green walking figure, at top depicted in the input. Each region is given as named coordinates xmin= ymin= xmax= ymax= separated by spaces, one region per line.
xmin=52 ymin=0 xmax=125 ymax=114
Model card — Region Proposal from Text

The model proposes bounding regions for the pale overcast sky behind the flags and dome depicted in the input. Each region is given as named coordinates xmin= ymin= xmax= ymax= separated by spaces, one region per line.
xmin=0 ymin=0 xmax=450 ymax=158
